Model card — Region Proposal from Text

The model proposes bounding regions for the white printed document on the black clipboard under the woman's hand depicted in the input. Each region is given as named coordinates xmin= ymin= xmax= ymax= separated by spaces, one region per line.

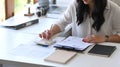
xmin=55 ymin=36 xmax=93 ymax=50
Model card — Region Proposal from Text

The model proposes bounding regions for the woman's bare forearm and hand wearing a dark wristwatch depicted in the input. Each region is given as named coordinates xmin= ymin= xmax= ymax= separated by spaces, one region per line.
xmin=83 ymin=34 xmax=120 ymax=43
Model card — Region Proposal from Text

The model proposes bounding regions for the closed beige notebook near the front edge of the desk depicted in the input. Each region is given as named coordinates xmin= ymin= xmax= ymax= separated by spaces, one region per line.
xmin=44 ymin=50 xmax=77 ymax=64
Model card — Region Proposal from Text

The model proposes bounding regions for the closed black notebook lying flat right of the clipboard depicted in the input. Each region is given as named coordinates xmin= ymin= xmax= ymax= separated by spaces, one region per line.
xmin=88 ymin=44 xmax=116 ymax=57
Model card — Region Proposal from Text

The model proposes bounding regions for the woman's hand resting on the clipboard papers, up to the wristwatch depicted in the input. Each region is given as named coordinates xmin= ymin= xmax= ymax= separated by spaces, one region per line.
xmin=83 ymin=35 xmax=105 ymax=43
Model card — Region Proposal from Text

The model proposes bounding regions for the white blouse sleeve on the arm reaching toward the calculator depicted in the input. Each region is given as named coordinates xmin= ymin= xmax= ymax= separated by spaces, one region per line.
xmin=57 ymin=0 xmax=76 ymax=31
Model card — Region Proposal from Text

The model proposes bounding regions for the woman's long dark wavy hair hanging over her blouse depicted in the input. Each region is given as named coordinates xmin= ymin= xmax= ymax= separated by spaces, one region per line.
xmin=76 ymin=0 xmax=107 ymax=31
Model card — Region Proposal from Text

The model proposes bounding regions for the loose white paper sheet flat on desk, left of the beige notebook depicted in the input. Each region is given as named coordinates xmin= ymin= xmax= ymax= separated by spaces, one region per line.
xmin=10 ymin=44 xmax=54 ymax=59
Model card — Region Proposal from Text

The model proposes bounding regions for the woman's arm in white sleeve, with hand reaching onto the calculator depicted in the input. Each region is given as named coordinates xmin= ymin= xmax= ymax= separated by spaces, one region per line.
xmin=39 ymin=1 xmax=76 ymax=39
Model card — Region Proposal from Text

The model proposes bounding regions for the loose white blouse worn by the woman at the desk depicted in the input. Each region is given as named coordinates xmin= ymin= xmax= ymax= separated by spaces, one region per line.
xmin=57 ymin=0 xmax=120 ymax=37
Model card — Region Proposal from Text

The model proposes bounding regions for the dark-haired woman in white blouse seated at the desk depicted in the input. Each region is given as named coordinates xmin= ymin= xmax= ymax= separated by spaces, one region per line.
xmin=39 ymin=0 xmax=120 ymax=43
